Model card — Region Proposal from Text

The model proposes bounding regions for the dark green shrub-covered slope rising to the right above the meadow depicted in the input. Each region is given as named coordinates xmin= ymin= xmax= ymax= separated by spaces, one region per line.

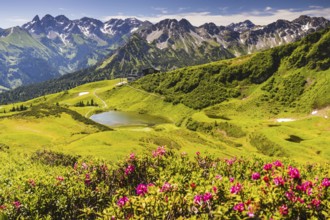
xmin=135 ymin=29 xmax=330 ymax=109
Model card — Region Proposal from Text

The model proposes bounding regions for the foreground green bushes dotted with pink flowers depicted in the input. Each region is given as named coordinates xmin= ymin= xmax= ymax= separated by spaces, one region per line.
xmin=0 ymin=147 xmax=330 ymax=219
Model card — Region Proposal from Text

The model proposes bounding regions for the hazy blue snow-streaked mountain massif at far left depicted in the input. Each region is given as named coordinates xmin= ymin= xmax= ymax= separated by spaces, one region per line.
xmin=0 ymin=15 xmax=144 ymax=88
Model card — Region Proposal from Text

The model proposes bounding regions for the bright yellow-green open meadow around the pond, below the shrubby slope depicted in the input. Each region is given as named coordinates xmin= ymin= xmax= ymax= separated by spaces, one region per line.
xmin=0 ymin=75 xmax=330 ymax=162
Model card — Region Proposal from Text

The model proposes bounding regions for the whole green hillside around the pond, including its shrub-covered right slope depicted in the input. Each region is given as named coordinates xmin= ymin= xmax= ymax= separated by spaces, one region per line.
xmin=0 ymin=30 xmax=330 ymax=163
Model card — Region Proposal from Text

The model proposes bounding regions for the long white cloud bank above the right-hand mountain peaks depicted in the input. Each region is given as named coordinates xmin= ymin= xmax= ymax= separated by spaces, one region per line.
xmin=101 ymin=8 xmax=330 ymax=26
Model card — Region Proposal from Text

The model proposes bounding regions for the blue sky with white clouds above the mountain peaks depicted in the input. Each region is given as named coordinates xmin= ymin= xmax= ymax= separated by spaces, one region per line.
xmin=0 ymin=0 xmax=330 ymax=28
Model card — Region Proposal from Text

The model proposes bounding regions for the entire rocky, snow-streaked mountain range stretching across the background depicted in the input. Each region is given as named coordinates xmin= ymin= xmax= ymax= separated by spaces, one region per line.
xmin=0 ymin=15 xmax=330 ymax=90
